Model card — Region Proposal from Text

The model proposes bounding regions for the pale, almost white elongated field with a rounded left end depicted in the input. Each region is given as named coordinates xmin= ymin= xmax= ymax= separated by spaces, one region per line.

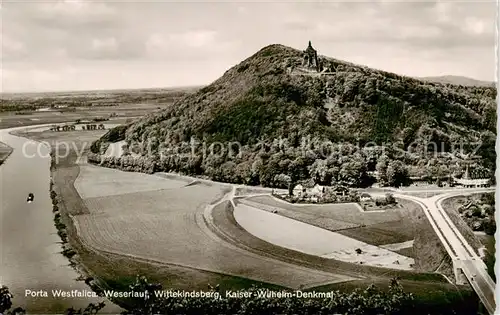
xmin=234 ymin=204 xmax=414 ymax=270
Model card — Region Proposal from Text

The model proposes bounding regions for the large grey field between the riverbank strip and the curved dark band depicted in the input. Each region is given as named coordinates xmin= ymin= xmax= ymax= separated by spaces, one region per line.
xmin=74 ymin=167 xmax=350 ymax=288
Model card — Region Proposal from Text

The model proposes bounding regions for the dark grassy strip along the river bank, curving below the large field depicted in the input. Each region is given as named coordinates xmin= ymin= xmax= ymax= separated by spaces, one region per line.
xmin=43 ymin=142 xmax=306 ymax=306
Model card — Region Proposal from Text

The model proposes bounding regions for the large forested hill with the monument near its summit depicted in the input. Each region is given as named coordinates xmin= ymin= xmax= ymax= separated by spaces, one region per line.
xmin=91 ymin=44 xmax=497 ymax=187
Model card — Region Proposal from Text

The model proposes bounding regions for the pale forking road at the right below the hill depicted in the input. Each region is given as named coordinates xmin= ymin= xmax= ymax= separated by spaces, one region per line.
xmin=394 ymin=188 xmax=495 ymax=314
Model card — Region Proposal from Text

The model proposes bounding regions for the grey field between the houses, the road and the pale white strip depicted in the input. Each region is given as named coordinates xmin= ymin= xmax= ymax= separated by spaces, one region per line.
xmin=244 ymin=196 xmax=453 ymax=277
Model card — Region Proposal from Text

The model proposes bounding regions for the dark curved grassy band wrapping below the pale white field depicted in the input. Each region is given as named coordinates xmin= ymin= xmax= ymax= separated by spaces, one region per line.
xmin=209 ymin=202 xmax=477 ymax=314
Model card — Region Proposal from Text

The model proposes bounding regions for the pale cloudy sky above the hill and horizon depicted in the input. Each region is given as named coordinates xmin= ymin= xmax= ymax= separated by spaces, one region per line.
xmin=0 ymin=0 xmax=497 ymax=92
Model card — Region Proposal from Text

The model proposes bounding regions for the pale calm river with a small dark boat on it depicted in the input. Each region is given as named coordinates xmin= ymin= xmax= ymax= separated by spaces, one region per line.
xmin=0 ymin=127 xmax=120 ymax=314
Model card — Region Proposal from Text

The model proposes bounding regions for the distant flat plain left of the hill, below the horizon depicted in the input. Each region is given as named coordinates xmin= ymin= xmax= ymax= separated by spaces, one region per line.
xmin=0 ymin=87 xmax=193 ymax=128
